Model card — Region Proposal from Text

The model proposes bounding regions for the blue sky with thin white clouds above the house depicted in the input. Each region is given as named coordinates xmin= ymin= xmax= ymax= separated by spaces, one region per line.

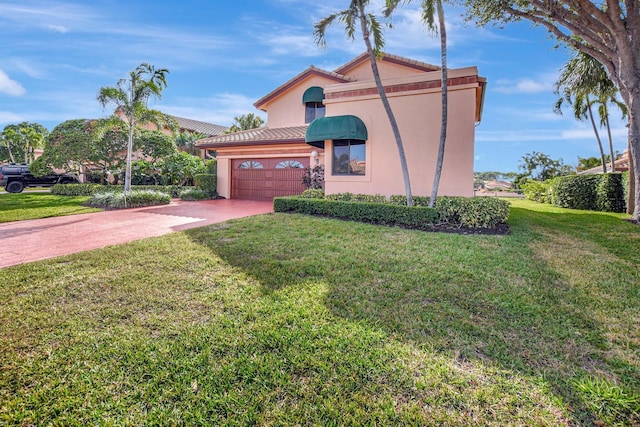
xmin=0 ymin=0 xmax=627 ymax=172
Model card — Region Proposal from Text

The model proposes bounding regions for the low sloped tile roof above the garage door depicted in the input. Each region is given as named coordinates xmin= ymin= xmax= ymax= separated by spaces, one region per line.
xmin=196 ymin=125 xmax=308 ymax=148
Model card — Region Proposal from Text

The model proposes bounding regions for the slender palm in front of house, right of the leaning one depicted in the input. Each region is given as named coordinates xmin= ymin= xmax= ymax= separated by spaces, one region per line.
xmin=384 ymin=0 xmax=449 ymax=208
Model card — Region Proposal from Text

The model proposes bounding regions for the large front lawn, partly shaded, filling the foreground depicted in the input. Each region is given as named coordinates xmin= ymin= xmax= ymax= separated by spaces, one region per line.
xmin=0 ymin=201 xmax=640 ymax=426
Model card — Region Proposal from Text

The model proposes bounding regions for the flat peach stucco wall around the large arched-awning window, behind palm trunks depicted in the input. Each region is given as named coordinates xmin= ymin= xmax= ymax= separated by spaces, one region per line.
xmin=325 ymin=69 xmax=477 ymax=196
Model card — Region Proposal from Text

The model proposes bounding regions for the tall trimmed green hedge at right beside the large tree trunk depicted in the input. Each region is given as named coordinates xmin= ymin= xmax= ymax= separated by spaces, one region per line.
xmin=522 ymin=173 xmax=629 ymax=212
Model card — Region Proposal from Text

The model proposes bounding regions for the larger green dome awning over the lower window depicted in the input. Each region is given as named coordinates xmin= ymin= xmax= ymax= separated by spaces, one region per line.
xmin=304 ymin=115 xmax=369 ymax=148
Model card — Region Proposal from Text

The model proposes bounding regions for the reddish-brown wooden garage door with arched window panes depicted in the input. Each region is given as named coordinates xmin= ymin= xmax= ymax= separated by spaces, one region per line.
xmin=231 ymin=157 xmax=309 ymax=200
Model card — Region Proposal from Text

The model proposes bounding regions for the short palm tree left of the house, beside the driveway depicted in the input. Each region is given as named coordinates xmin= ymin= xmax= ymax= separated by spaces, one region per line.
xmin=98 ymin=63 xmax=170 ymax=193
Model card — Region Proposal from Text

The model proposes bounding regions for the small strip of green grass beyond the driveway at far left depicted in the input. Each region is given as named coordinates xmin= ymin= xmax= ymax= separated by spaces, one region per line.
xmin=0 ymin=191 xmax=102 ymax=222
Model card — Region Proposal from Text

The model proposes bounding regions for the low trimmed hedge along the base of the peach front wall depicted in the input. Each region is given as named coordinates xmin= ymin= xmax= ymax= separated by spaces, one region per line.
xmin=274 ymin=190 xmax=509 ymax=229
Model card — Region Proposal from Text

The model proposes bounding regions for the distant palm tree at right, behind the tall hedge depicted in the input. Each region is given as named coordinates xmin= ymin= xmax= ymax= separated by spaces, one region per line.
xmin=554 ymin=52 xmax=627 ymax=173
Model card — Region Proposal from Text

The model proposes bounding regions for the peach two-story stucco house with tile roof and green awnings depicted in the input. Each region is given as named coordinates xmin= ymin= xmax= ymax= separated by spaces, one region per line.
xmin=197 ymin=54 xmax=486 ymax=200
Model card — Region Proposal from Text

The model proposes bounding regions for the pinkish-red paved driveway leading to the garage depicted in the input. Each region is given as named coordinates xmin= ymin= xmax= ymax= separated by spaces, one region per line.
xmin=0 ymin=200 xmax=273 ymax=268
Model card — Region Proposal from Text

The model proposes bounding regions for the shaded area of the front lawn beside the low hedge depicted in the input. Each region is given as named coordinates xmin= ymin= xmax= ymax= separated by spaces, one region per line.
xmin=182 ymin=208 xmax=640 ymax=424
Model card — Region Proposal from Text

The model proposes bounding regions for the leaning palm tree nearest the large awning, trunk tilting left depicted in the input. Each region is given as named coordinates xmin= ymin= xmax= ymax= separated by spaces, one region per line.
xmin=313 ymin=0 xmax=413 ymax=206
